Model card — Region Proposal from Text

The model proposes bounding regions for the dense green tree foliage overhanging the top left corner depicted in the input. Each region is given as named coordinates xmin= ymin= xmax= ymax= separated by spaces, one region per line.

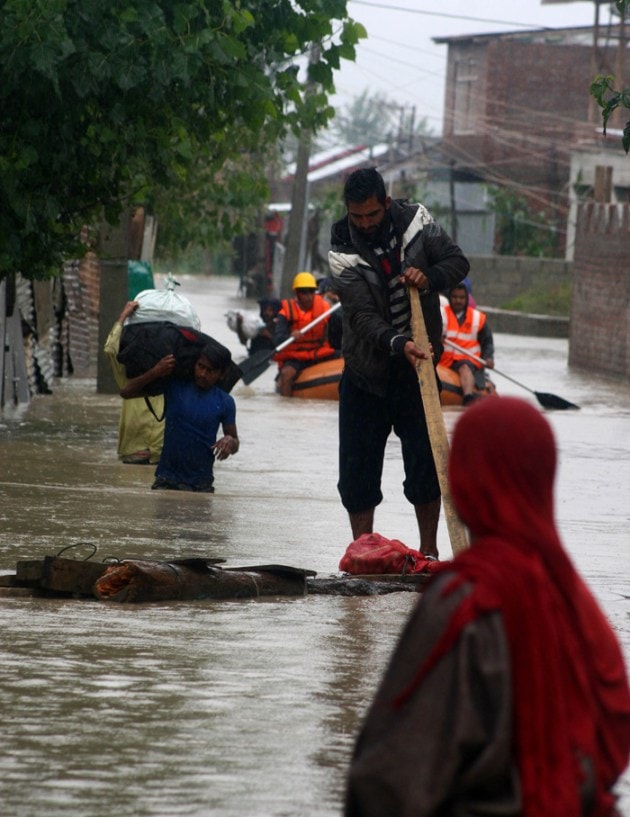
xmin=0 ymin=0 xmax=365 ymax=277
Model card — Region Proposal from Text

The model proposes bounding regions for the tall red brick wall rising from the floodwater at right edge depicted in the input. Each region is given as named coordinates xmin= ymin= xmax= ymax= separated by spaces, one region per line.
xmin=569 ymin=207 xmax=630 ymax=380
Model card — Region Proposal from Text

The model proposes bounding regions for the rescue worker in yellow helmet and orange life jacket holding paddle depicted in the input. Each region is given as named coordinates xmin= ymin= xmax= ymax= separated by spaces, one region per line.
xmin=273 ymin=272 xmax=339 ymax=397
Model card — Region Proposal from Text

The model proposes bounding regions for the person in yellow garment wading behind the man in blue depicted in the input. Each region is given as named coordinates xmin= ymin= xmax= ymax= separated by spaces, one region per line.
xmin=104 ymin=301 xmax=164 ymax=465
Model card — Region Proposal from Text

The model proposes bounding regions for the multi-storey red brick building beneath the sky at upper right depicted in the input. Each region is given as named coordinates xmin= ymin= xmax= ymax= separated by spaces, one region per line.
xmin=434 ymin=27 xmax=626 ymax=253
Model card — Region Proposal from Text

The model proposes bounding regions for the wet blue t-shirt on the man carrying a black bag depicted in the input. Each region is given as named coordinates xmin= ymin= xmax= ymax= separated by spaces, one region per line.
xmin=155 ymin=379 xmax=236 ymax=485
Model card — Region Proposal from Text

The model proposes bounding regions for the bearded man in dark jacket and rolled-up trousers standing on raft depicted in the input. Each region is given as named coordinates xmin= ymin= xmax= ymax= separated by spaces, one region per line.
xmin=328 ymin=168 xmax=470 ymax=558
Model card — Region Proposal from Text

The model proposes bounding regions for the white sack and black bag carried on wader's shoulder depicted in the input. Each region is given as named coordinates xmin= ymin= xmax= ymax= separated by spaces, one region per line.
xmin=117 ymin=275 xmax=241 ymax=394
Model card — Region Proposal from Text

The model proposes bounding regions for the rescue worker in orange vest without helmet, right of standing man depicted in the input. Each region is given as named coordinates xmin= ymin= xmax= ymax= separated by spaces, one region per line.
xmin=440 ymin=284 xmax=494 ymax=406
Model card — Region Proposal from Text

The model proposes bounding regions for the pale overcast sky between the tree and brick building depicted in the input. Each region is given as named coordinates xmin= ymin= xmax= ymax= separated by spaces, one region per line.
xmin=331 ymin=0 xmax=609 ymax=135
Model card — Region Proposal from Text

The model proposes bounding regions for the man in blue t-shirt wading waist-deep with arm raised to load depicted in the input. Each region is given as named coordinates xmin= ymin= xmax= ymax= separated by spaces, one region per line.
xmin=120 ymin=342 xmax=239 ymax=493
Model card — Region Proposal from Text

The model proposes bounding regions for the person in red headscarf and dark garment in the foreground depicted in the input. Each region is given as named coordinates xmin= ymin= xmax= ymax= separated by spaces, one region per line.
xmin=345 ymin=397 xmax=630 ymax=817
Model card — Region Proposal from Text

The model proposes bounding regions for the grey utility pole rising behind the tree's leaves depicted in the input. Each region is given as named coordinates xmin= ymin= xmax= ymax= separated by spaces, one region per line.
xmin=280 ymin=44 xmax=319 ymax=298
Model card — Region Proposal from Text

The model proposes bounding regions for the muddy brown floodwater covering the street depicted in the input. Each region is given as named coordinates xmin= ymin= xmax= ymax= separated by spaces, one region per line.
xmin=0 ymin=278 xmax=630 ymax=817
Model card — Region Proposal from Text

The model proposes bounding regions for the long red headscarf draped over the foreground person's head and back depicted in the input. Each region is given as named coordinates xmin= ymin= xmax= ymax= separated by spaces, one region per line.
xmin=401 ymin=397 xmax=630 ymax=817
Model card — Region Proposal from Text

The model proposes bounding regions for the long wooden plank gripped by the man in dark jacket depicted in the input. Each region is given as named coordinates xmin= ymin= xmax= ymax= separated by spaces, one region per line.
xmin=409 ymin=287 xmax=468 ymax=556
